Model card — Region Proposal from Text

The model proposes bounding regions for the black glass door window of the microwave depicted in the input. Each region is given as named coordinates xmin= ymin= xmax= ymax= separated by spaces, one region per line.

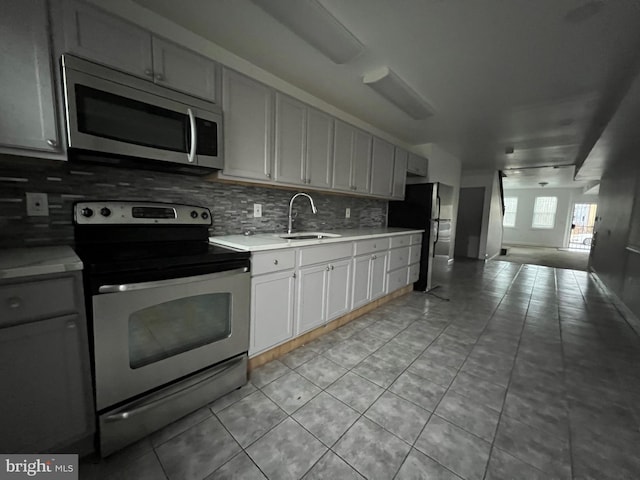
xmin=75 ymin=85 xmax=190 ymax=153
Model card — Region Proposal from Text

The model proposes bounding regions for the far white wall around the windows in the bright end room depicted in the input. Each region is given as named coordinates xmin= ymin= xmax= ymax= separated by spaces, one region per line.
xmin=503 ymin=188 xmax=598 ymax=248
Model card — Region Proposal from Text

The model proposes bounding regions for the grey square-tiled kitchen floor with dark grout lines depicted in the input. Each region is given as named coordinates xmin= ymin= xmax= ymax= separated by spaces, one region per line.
xmin=81 ymin=262 xmax=640 ymax=480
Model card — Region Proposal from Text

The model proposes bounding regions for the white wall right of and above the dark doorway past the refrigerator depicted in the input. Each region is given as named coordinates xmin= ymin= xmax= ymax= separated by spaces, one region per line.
xmin=462 ymin=171 xmax=502 ymax=260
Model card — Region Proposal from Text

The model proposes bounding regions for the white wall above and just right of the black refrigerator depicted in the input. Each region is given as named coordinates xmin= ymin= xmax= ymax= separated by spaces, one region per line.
xmin=407 ymin=143 xmax=462 ymax=259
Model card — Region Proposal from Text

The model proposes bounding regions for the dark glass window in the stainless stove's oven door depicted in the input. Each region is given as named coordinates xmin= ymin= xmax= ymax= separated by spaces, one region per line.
xmin=129 ymin=293 xmax=231 ymax=369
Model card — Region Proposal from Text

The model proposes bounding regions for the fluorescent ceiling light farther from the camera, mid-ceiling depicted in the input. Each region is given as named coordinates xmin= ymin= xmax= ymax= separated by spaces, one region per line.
xmin=362 ymin=67 xmax=434 ymax=120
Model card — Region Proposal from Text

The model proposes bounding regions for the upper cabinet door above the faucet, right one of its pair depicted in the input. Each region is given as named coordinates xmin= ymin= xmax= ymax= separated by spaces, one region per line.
xmin=305 ymin=108 xmax=333 ymax=188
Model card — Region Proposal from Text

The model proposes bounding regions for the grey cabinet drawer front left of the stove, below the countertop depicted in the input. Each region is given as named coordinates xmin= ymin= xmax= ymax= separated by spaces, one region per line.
xmin=0 ymin=277 xmax=77 ymax=327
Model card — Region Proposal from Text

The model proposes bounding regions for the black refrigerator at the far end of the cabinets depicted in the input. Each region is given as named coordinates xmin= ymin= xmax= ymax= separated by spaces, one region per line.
xmin=387 ymin=182 xmax=453 ymax=292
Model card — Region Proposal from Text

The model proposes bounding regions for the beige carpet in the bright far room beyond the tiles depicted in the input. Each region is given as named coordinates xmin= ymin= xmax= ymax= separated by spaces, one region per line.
xmin=494 ymin=245 xmax=589 ymax=271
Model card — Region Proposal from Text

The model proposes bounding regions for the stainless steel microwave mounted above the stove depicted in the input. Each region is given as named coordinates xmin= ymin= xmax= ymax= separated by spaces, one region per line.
xmin=62 ymin=55 xmax=224 ymax=171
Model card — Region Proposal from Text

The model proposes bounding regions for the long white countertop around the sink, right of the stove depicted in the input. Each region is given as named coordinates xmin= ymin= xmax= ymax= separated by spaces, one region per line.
xmin=209 ymin=228 xmax=424 ymax=252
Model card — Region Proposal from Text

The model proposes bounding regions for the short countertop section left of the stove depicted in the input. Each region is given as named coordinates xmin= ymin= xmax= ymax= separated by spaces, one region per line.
xmin=0 ymin=245 xmax=82 ymax=279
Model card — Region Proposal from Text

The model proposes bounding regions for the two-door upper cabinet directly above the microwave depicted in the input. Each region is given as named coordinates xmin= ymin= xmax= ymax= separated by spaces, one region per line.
xmin=64 ymin=0 xmax=218 ymax=101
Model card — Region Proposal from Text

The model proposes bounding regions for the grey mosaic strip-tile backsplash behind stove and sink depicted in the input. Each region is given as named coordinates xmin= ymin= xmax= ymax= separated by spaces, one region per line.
xmin=0 ymin=154 xmax=387 ymax=247
